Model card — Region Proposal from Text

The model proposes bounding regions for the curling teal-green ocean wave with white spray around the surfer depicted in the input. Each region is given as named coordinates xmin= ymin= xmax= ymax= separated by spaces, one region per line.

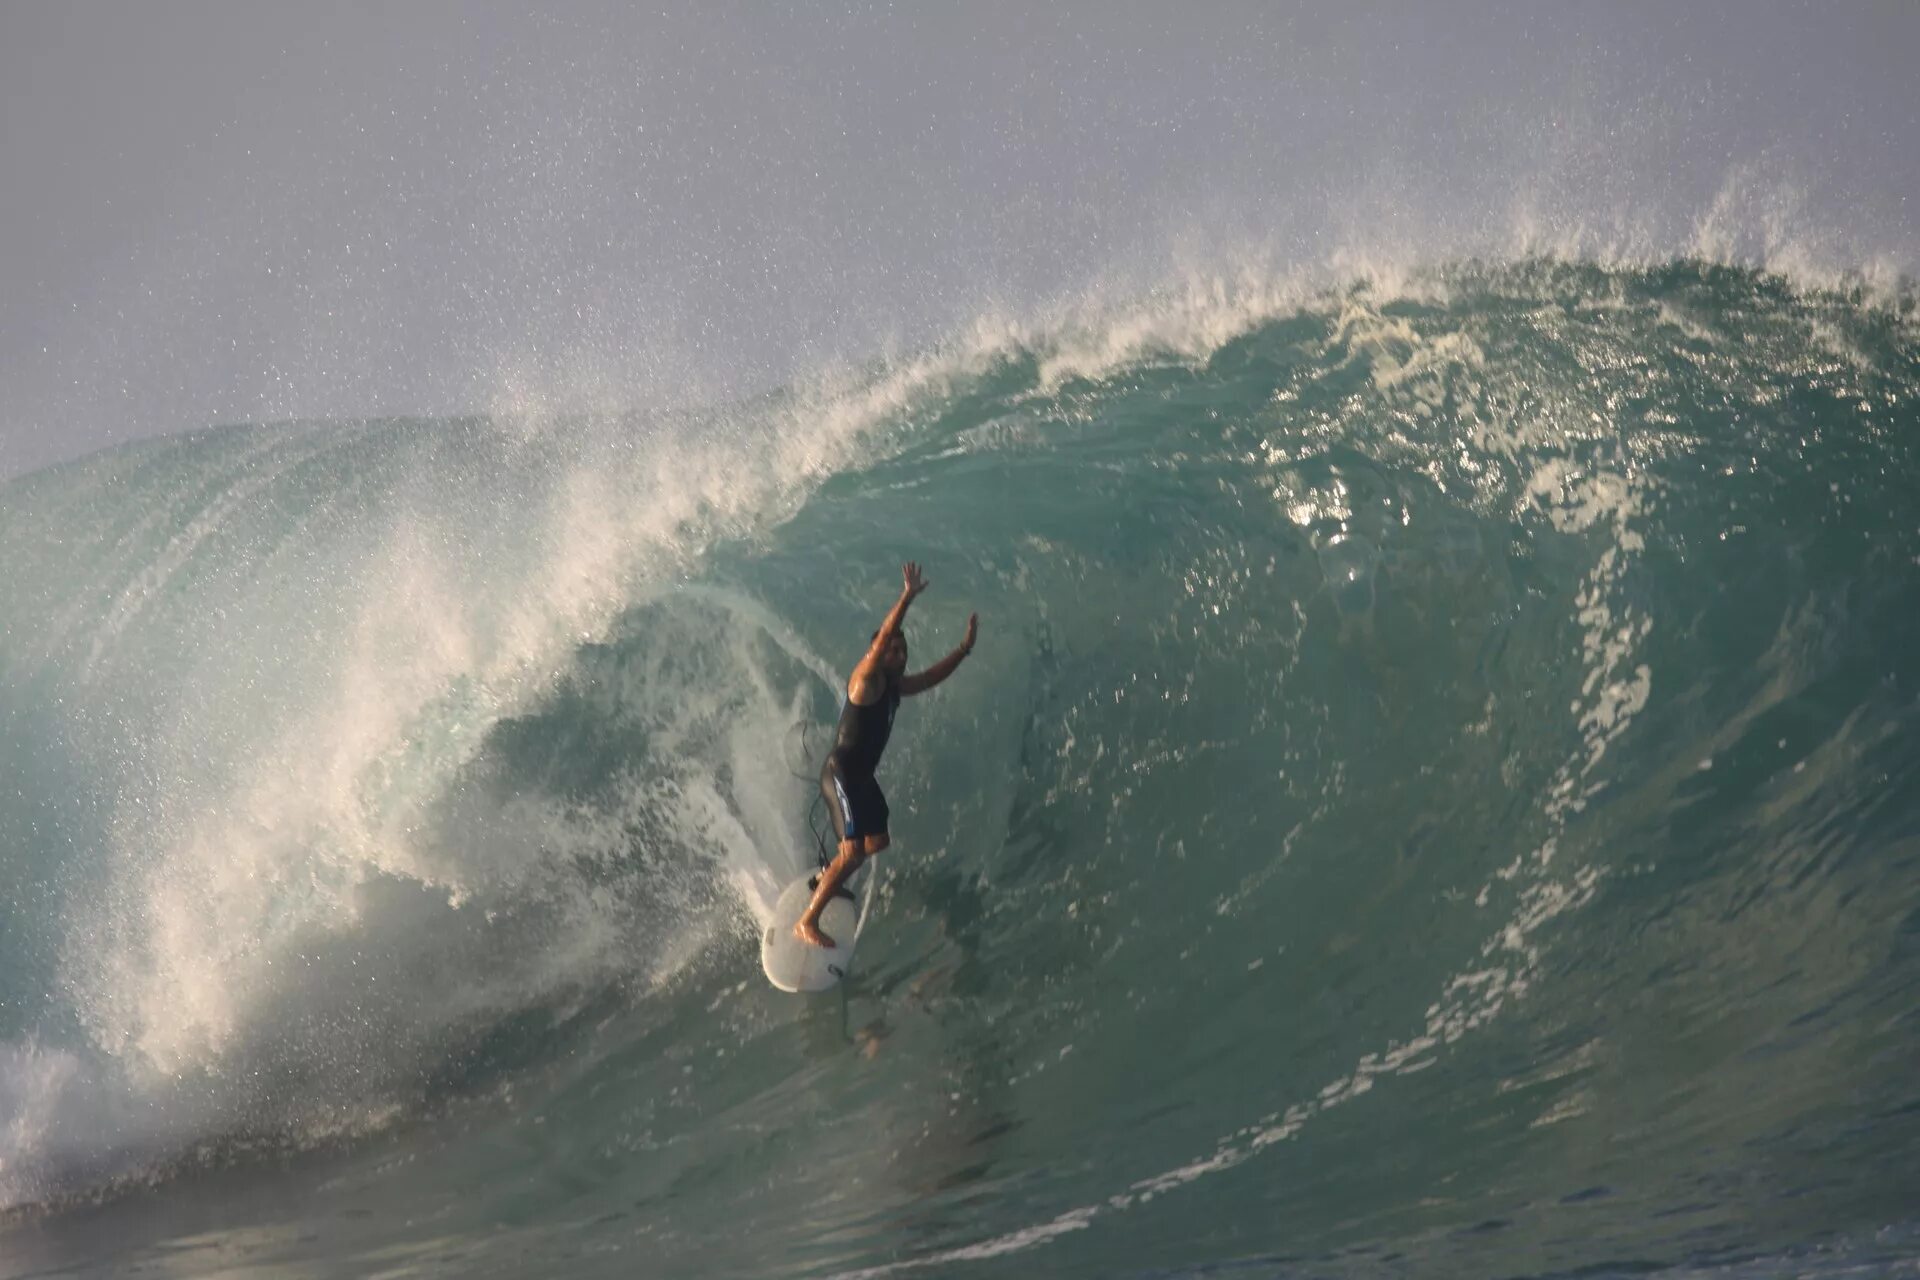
xmin=0 ymin=257 xmax=1920 ymax=1280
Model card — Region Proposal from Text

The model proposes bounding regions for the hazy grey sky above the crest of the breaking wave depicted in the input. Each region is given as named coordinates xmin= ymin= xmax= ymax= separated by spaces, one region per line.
xmin=0 ymin=0 xmax=1920 ymax=476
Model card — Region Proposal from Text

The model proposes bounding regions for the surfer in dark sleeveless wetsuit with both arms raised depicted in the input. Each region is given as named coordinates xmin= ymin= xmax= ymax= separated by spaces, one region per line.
xmin=793 ymin=560 xmax=979 ymax=946
